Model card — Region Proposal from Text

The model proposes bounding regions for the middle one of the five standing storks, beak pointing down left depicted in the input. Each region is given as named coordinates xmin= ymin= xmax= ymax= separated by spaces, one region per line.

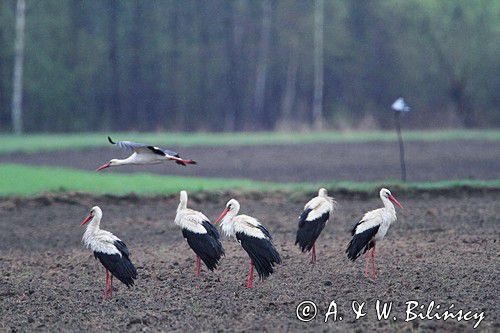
xmin=215 ymin=199 xmax=281 ymax=288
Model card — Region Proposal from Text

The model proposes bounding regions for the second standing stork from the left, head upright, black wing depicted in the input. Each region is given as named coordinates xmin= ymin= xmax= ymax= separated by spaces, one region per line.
xmin=175 ymin=191 xmax=224 ymax=276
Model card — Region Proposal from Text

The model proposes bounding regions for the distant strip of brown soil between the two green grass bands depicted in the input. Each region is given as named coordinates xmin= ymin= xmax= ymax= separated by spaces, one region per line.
xmin=0 ymin=140 xmax=500 ymax=182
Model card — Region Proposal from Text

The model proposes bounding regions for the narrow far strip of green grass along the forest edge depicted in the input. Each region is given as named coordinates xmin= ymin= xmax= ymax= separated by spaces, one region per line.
xmin=0 ymin=130 xmax=500 ymax=153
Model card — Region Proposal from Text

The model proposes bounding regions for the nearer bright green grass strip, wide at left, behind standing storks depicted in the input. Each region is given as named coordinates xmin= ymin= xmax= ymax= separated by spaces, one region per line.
xmin=0 ymin=164 xmax=500 ymax=196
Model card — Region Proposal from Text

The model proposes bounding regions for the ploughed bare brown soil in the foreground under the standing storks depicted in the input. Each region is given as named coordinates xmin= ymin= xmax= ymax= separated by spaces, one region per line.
xmin=0 ymin=192 xmax=500 ymax=332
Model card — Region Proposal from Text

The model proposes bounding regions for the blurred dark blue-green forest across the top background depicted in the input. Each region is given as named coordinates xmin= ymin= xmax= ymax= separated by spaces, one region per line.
xmin=0 ymin=0 xmax=500 ymax=131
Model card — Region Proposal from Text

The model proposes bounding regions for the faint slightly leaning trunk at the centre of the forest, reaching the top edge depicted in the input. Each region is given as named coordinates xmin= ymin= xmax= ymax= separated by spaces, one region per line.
xmin=254 ymin=0 xmax=272 ymax=128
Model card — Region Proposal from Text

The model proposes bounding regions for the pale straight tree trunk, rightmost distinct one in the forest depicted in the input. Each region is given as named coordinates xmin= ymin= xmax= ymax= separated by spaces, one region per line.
xmin=312 ymin=0 xmax=324 ymax=129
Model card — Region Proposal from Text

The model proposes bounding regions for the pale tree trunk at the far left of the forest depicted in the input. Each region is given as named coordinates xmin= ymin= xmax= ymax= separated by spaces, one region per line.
xmin=12 ymin=0 xmax=26 ymax=134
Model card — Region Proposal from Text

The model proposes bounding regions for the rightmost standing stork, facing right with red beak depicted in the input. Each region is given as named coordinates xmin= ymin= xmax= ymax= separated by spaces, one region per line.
xmin=346 ymin=188 xmax=403 ymax=278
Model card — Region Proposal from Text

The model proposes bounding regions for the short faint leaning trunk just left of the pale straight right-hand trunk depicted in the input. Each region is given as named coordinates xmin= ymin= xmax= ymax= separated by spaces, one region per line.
xmin=281 ymin=40 xmax=299 ymax=129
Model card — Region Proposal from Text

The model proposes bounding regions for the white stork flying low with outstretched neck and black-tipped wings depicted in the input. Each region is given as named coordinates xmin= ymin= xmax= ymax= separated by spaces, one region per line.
xmin=96 ymin=136 xmax=196 ymax=171
